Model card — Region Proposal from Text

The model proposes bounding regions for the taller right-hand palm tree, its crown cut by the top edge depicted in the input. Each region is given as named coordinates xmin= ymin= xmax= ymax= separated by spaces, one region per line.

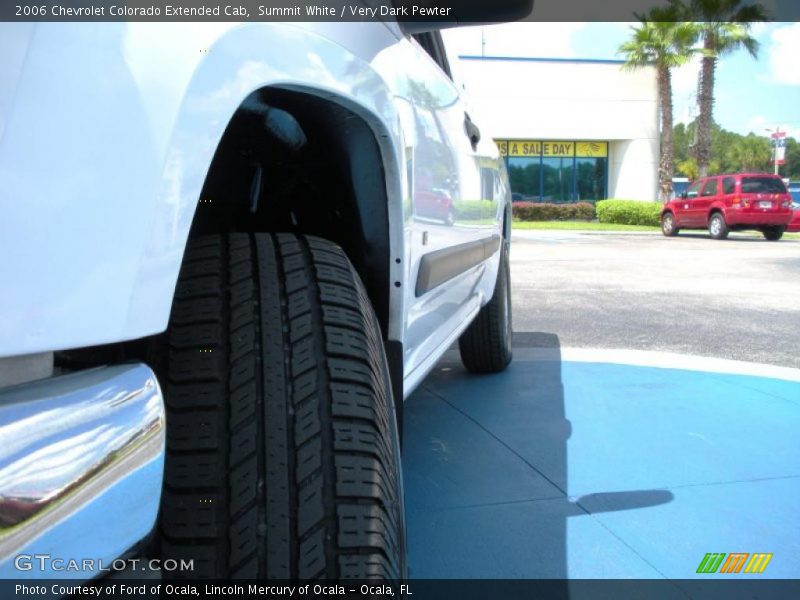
xmin=670 ymin=0 xmax=767 ymax=177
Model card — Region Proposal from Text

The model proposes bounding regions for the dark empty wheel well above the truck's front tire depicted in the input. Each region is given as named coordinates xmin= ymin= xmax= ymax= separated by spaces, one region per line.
xmin=194 ymin=88 xmax=394 ymax=339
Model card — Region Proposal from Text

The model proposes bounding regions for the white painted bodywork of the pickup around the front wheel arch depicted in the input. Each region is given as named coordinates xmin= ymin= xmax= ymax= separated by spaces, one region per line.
xmin=0 ymin=23 xmax=508 ymax=392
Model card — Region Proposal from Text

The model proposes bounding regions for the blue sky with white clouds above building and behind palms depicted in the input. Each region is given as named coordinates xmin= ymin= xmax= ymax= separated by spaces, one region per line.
xmin=445 ymin=23 xmax=800 ymax=140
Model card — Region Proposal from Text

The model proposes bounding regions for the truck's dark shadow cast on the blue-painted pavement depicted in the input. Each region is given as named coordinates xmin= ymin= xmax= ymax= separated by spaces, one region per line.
xmin=403 ymin=332 xmax=673 ymax=580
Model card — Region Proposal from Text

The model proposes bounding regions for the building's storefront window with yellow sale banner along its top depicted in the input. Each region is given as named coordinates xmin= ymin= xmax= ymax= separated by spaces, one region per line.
xmin=497 ymin=140 xmax=608 ymax=203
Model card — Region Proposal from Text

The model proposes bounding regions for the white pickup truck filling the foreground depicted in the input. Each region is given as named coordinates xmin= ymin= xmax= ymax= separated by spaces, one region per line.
xmin=0 ymin=0 xmax=530 ymax=579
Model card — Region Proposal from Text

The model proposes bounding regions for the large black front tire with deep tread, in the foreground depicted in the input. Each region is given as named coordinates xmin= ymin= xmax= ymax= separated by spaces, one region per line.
xmin=159 ymin=233 xmax=405 ymax=580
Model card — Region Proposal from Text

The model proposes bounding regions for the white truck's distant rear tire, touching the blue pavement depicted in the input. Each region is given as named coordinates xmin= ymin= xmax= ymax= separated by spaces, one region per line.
xmin=458 ymin=241 xmax=512 ymax=373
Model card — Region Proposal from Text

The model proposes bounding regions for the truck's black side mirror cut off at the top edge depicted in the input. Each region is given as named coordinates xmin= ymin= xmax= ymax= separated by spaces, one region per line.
xmin=392 ymin=0 xmax=534 ymax=34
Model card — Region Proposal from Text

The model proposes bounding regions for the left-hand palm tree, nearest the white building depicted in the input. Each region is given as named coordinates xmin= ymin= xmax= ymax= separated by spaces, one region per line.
xmin=618 ymin=8 xmax=697 ymax=201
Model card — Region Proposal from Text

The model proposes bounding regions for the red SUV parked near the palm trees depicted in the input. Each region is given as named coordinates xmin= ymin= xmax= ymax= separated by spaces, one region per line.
xmin=661 ymin=173 xmax=792 ymax=241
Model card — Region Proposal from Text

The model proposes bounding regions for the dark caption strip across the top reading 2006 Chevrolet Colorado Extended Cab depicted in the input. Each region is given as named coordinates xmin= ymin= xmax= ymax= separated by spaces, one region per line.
xmin=0 ymin=0 xmax=800 ymax=26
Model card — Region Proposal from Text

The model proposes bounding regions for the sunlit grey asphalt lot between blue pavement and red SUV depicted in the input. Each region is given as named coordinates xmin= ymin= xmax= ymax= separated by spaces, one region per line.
xmin=511 ymin=231 xmax=800 ymax=367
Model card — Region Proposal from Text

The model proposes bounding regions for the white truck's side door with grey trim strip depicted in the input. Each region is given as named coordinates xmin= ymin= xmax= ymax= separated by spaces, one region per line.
xmin=392 ymin=32 xmax=505 ymax=374
